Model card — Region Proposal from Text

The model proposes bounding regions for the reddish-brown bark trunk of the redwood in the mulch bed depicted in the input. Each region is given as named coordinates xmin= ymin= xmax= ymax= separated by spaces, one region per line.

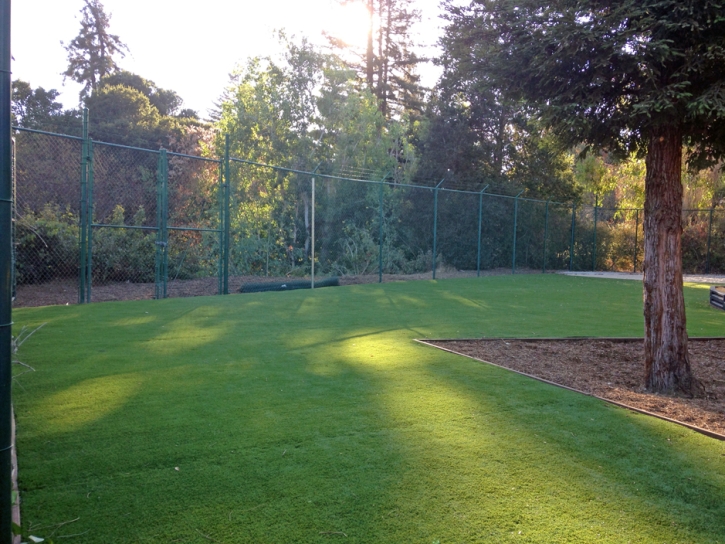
xmin=644 ymin=126 xmax=694 ymax=394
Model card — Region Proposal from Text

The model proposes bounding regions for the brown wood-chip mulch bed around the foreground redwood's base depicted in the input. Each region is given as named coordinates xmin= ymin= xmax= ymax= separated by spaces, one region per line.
xmin=429 ymin=338 xmax=725 ymax=435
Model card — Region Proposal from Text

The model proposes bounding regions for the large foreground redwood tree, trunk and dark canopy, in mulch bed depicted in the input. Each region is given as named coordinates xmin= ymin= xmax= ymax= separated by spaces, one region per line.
xmin=447 ymin=0 xmax=725 ymax=393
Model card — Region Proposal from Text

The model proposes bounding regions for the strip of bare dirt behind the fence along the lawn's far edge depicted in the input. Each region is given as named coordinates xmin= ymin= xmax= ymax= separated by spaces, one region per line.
xmin=13 ymin=268 xmax=540 ymax=308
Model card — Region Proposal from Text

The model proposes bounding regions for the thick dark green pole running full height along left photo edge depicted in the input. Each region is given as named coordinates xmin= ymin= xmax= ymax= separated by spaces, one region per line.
xmin=0 ymin=0 xmax=13 ymax=543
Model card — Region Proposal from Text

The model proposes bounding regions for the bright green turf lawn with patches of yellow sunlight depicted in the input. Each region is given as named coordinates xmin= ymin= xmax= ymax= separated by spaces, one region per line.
xmin=14 ymin=275 xmax=725 ymax=544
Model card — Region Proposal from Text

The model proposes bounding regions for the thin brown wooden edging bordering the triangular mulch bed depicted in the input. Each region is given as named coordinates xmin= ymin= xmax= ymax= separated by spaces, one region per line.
xmin=415 ymin=336 xmax=725 ymax=441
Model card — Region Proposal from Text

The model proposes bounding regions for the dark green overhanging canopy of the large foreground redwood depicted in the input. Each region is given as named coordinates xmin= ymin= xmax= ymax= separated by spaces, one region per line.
xmin=448 ymin=0 xmax=725 ymax=163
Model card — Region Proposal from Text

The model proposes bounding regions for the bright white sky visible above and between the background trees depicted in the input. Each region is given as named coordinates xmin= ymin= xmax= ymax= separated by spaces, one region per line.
xmin=12 ymin=0 xmax=441 ymax=117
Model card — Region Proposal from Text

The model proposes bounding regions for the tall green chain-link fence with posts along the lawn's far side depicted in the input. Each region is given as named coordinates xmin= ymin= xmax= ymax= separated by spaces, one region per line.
xmin=14 ymin=129 xmax=725 ymax=305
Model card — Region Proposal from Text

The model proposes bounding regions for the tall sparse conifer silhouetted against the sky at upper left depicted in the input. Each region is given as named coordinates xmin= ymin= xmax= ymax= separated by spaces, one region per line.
xmin=61 ymin=0 xmax=128 ymax=98
